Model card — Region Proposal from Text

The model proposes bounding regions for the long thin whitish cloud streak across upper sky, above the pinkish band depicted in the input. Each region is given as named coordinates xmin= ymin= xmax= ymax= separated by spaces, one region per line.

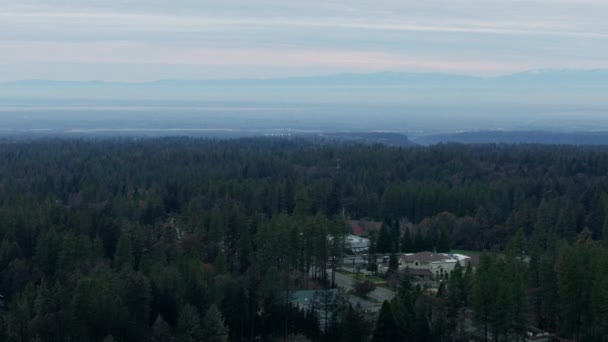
xmin=0 ymin=11 xmax=608 ymax=39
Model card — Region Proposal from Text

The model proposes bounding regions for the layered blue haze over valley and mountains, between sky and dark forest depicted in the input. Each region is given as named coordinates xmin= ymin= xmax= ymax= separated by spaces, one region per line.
xmin=0 ymin=70 xmax=608 ymax=143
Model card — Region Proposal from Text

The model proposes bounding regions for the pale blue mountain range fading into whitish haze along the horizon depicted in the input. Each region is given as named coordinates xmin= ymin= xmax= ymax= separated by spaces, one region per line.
xmin=0 ymin=70 xmax=608 ymax=105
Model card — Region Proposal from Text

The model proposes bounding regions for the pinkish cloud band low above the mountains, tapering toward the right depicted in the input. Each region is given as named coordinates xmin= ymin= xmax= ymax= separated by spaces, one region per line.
xmin=0 ymin=42 xmax=520 ymax=73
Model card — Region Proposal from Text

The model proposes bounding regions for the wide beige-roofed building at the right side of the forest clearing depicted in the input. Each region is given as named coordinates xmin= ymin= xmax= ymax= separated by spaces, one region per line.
xmin=401 ymin=252 xmax=471 ymax=279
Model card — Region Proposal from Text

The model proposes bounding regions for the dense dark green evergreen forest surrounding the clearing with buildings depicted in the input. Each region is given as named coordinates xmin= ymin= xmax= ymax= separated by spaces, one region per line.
xmin=0 ymin=138 xmax=608 ymax=341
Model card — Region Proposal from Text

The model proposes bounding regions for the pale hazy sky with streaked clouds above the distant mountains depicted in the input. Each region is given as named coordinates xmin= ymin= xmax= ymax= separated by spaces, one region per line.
xmin=0 ymin=0 xmax=608 ymax=81
